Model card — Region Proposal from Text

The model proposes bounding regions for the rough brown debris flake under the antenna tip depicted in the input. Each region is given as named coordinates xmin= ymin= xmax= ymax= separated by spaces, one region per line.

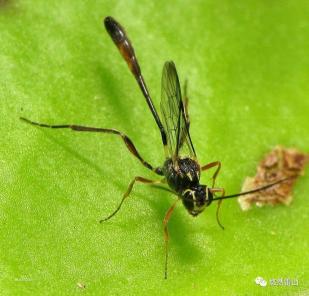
xmin=238 ymin=146 xmax=309 ymax=211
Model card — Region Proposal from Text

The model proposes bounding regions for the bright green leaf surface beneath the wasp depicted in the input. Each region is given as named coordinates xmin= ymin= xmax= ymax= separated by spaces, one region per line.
xmin=0 ymin=0 xmax=309 ymax=295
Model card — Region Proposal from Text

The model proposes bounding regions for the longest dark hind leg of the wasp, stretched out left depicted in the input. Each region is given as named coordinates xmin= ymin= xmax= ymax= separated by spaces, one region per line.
xmin=20 ymin=117 xmax=163 ymax=176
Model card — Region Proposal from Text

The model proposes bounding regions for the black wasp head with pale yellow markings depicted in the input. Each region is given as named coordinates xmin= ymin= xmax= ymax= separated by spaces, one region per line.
xmin=182 ymin=185 xmax=213 ymax=216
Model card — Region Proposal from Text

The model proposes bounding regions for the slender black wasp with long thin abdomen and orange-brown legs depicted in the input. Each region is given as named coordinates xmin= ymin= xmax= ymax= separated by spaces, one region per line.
xmin=20 ymin=16 xmax=292 ymax=278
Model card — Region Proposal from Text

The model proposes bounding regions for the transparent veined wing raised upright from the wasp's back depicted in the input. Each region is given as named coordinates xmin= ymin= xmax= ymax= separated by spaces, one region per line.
xmin=161 ymin=61 xmax=196 ymax=162
